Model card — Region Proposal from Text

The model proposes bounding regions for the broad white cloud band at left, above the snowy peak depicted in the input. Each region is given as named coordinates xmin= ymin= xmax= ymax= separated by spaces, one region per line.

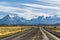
xmin=0 ymin=5 xmax=27 ymax=13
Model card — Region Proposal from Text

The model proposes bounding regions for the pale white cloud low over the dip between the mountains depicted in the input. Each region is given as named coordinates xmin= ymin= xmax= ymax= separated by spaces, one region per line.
xmin=19 ymin=11 xmax=54 ymax=20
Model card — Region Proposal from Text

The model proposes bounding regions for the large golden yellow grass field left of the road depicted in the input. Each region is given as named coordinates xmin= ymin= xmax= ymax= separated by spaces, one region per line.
xmin=0 ymin=26 xmax=31 ymax=38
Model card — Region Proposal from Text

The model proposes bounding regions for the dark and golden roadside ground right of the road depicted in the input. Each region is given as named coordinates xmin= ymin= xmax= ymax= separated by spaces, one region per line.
xmin=45 ymin=26 xmax=60 ymax=38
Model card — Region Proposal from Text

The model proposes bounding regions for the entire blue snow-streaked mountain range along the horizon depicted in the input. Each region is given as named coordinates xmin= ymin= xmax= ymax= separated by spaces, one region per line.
xmin=0 ymin=15 xmax=60 ymax=25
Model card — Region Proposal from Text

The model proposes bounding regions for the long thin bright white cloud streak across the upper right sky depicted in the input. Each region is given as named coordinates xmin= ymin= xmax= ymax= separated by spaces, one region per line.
xmin=22 ymin=4 xmax=60 ymax=10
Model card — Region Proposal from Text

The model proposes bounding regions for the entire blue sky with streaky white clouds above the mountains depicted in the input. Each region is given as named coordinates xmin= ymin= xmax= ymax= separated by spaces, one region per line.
xmin=0 ymin=0 xmax=60 ymax=20
